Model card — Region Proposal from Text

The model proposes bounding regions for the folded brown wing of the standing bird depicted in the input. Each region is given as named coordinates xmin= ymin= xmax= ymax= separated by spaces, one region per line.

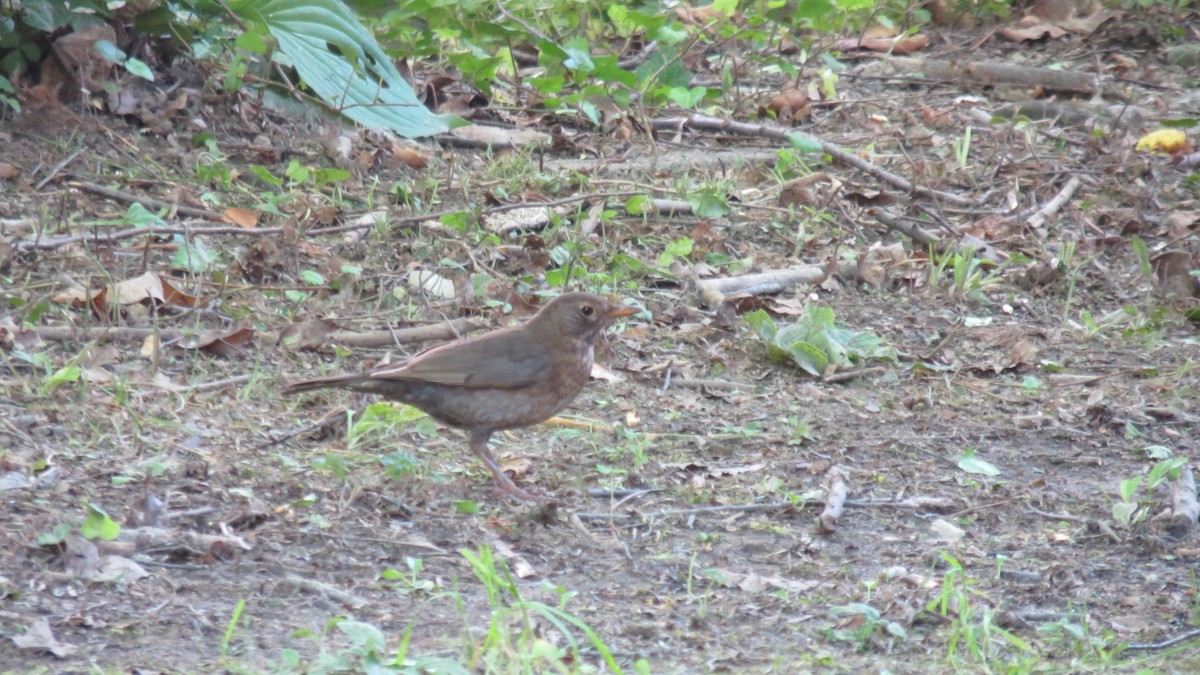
xmin=371 ymin=333 xmax=551 ymax=389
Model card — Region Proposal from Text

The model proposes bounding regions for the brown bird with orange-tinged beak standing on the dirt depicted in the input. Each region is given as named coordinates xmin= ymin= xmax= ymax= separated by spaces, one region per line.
xmin=287 ymin=293 xmax=637 ymax=501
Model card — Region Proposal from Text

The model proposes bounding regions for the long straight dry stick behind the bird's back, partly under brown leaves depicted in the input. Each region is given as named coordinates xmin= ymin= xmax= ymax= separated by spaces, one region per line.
xmin=30 ymin=318 xmax=482 ymax=347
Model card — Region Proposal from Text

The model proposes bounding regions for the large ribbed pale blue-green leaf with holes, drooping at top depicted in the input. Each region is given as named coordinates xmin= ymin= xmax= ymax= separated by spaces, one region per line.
xmin=232 ymin=0 xmax=451 ymax=138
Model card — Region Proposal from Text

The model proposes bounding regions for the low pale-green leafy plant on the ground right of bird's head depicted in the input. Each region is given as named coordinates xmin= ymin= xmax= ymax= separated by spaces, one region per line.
xmin=742 ymin=304 xmax=894 ymax=377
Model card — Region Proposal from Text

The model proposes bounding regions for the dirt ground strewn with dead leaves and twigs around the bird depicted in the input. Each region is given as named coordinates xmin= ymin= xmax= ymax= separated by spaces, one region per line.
xmin=0 ymin=7 xmax=1200 ymax=673
